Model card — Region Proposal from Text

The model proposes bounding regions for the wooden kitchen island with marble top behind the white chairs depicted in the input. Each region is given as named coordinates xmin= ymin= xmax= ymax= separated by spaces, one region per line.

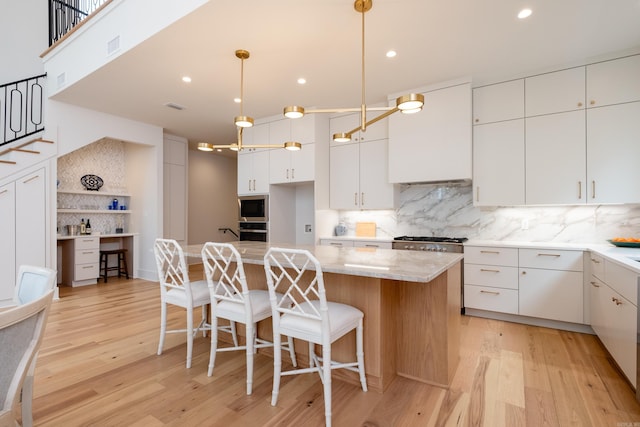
xmin=184 ymin=242 xmax=462 ymax=392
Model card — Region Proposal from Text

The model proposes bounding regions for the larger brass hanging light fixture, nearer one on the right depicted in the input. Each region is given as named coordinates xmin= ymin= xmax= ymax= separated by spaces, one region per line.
xmin=284 ymin=0 xmax=424 ymax=142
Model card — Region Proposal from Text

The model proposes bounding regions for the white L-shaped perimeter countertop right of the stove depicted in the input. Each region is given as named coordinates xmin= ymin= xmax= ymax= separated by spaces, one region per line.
xmin=464 ymin=240 xmax=640 ymax=274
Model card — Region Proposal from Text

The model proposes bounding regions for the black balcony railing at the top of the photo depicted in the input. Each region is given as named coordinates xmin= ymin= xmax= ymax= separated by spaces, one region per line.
xmin=49 ymin=0 xmax=109 ymax=46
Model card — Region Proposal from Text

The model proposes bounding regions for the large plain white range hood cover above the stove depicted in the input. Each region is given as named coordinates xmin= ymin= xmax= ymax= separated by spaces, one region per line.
xmin=388 ymin=83 xmax=472 ymax=183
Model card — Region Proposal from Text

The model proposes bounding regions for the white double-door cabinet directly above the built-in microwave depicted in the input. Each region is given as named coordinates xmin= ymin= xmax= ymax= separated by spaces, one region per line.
xmin=238 ymin=149 xmax=269 ymax=196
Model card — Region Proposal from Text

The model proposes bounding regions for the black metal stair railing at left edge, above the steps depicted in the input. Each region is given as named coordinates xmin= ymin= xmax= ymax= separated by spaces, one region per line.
xmin=0 ymin=74 xmax=47 ymax=150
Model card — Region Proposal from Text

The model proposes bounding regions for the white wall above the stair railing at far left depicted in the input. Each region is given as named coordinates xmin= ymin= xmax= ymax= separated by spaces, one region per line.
xmin=0 ymin=0 xmax=49 ymax=84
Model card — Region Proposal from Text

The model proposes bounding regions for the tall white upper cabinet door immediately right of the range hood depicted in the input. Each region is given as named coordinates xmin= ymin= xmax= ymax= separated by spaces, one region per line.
xmin=473 ymin=119 xmax=525 ymax=206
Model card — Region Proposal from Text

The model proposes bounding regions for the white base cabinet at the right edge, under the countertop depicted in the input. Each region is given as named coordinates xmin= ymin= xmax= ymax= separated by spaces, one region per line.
xmin=590 ymin=260 xmax=638 ymax=387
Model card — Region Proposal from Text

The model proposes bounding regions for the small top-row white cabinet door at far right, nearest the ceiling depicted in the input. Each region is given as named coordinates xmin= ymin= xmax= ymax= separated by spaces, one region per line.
xmin=587 ymin=55 xmax=640 ymax=108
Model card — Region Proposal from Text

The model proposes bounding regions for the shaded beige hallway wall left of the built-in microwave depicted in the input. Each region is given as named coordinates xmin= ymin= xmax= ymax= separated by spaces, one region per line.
xmin=187 ymin=150 xmax=238 ymax=244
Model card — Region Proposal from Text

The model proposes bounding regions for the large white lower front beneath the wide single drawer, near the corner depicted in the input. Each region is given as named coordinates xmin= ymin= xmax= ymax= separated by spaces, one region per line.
xmin=518 ymin=268 xmax=583 ymax=323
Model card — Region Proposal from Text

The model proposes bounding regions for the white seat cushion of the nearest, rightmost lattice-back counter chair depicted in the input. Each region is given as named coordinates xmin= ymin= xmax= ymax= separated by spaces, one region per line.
xmin=280 ymin=300 xmax=364 ymax=344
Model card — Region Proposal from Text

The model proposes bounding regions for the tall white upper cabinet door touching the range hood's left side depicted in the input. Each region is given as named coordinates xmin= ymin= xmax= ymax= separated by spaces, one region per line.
xmin=360 ymin=139 xmax=396 ymax=209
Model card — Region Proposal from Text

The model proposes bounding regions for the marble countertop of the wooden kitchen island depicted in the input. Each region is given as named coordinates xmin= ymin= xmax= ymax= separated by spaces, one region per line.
xmin=183 ymin=241 xmax=463 ymax=283
